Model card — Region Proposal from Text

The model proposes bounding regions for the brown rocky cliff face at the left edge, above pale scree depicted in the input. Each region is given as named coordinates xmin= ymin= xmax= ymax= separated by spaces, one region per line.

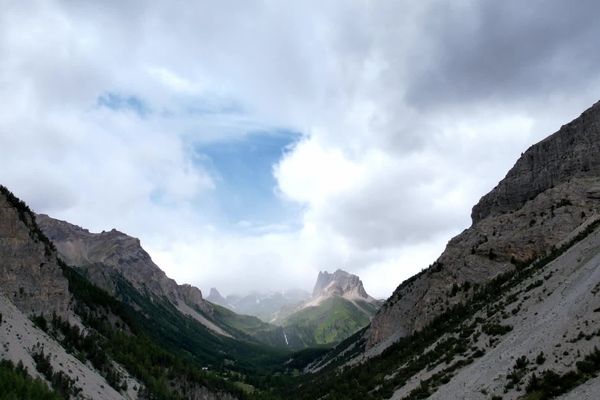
xmin=0 ymin=186 xmax=70 ymax=316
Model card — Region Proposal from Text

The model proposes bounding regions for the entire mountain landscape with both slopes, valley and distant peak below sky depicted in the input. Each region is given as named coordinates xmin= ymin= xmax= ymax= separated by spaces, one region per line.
xmin=0 ymin=103 xmax=600 ymax=400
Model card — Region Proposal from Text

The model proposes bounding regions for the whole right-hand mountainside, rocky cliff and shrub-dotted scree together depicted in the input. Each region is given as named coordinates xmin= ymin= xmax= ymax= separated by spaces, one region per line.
xmin=283 ymin=103 xmax=600 ymax=399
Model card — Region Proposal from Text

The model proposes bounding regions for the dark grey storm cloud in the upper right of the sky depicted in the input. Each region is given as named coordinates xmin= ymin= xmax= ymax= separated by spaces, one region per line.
xmin=406 ymin=0 xmax=600 ymax=108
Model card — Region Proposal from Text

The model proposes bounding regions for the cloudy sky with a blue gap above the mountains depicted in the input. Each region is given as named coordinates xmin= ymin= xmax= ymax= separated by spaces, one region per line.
xmin=0 ymin=0 xmax=600 ymax=298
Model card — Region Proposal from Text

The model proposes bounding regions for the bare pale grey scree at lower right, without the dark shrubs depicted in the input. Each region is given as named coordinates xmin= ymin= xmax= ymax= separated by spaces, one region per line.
xmin=392 ymin=219 xmax=600 ymax=400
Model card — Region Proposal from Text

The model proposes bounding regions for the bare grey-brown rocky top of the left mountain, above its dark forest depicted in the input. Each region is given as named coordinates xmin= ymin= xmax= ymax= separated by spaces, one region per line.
xmin=37 ymin=215 xmax=211 ymax=313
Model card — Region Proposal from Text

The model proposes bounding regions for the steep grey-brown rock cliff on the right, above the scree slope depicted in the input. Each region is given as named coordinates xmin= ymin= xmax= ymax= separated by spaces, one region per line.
xmin=366 ymin=103 xmax=600 ymax=347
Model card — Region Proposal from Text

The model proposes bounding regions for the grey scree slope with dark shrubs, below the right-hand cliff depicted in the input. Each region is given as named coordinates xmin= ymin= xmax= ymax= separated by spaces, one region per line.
xmin=282 ymin=216 xmax=600 ymax=400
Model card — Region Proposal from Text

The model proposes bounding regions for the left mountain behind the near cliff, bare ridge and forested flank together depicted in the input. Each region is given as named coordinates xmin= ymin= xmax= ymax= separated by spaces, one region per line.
xmin=38 ymin=215 xmax=298 ymax=362
